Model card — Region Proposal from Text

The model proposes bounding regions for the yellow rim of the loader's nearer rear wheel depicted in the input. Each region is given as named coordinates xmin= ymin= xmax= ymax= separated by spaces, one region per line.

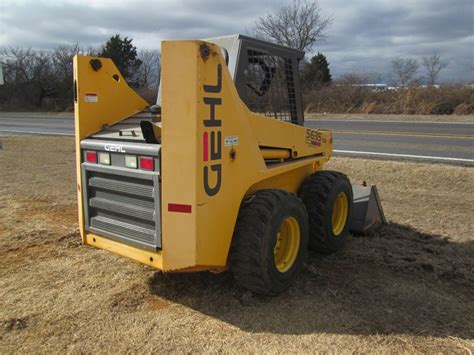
xmin=273 ymin=217 xmax=301 ymax=272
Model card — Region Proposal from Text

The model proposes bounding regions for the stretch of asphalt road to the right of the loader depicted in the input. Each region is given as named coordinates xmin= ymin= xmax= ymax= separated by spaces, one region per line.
xmin=306 ymin=120 xmax=474 ymax=165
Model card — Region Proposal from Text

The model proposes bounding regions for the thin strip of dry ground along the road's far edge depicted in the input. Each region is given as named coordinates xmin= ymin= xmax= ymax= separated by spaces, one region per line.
xmin=305 ymin=113 xmax=474 ymax=123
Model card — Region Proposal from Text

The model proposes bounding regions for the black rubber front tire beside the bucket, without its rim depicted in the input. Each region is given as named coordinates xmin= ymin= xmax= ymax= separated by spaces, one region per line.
xmin=300 ymin=171 xmax=353 ymax=254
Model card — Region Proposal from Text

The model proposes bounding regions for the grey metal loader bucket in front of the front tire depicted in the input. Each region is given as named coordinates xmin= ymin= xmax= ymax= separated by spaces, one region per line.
xmin=349 ymin=185 xmax=387 ymax=234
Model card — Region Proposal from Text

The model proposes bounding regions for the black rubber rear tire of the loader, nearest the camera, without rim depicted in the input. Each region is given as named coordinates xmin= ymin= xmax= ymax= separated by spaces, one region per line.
xmin=229 ymin=190 xmax=309 ymax=296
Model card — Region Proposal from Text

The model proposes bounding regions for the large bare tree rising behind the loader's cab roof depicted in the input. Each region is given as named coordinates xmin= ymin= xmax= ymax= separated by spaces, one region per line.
xmin=254 ymin=0 xmax=332 ymax=51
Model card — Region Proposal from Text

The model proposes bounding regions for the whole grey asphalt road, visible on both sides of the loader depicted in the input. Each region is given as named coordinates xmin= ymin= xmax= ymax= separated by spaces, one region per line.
xmin=0 ymin=113 xmax=474 ymax=166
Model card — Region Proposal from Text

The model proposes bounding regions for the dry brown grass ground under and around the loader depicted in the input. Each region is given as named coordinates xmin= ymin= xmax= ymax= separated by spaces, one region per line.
xmin=0 ymin=137 xmax=474 ymax=354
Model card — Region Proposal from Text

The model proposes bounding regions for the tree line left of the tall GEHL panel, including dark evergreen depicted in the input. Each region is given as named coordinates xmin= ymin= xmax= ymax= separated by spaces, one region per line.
xmin=0 ymin=35 xmax=160 ymax=111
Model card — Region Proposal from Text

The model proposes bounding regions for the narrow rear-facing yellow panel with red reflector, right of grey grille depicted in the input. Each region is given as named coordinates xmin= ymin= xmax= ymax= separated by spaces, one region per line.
xmin=161 ymin=42 xmax=198 ymax=270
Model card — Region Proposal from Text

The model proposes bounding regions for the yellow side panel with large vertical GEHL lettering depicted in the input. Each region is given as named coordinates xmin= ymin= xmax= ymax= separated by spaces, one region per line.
xmin=196 ymin=44 xmax=267 ymax=266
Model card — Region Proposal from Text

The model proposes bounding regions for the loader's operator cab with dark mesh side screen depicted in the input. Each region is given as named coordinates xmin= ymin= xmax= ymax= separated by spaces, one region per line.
xmin=157 ymin=34 xmax=304 ymax=126
